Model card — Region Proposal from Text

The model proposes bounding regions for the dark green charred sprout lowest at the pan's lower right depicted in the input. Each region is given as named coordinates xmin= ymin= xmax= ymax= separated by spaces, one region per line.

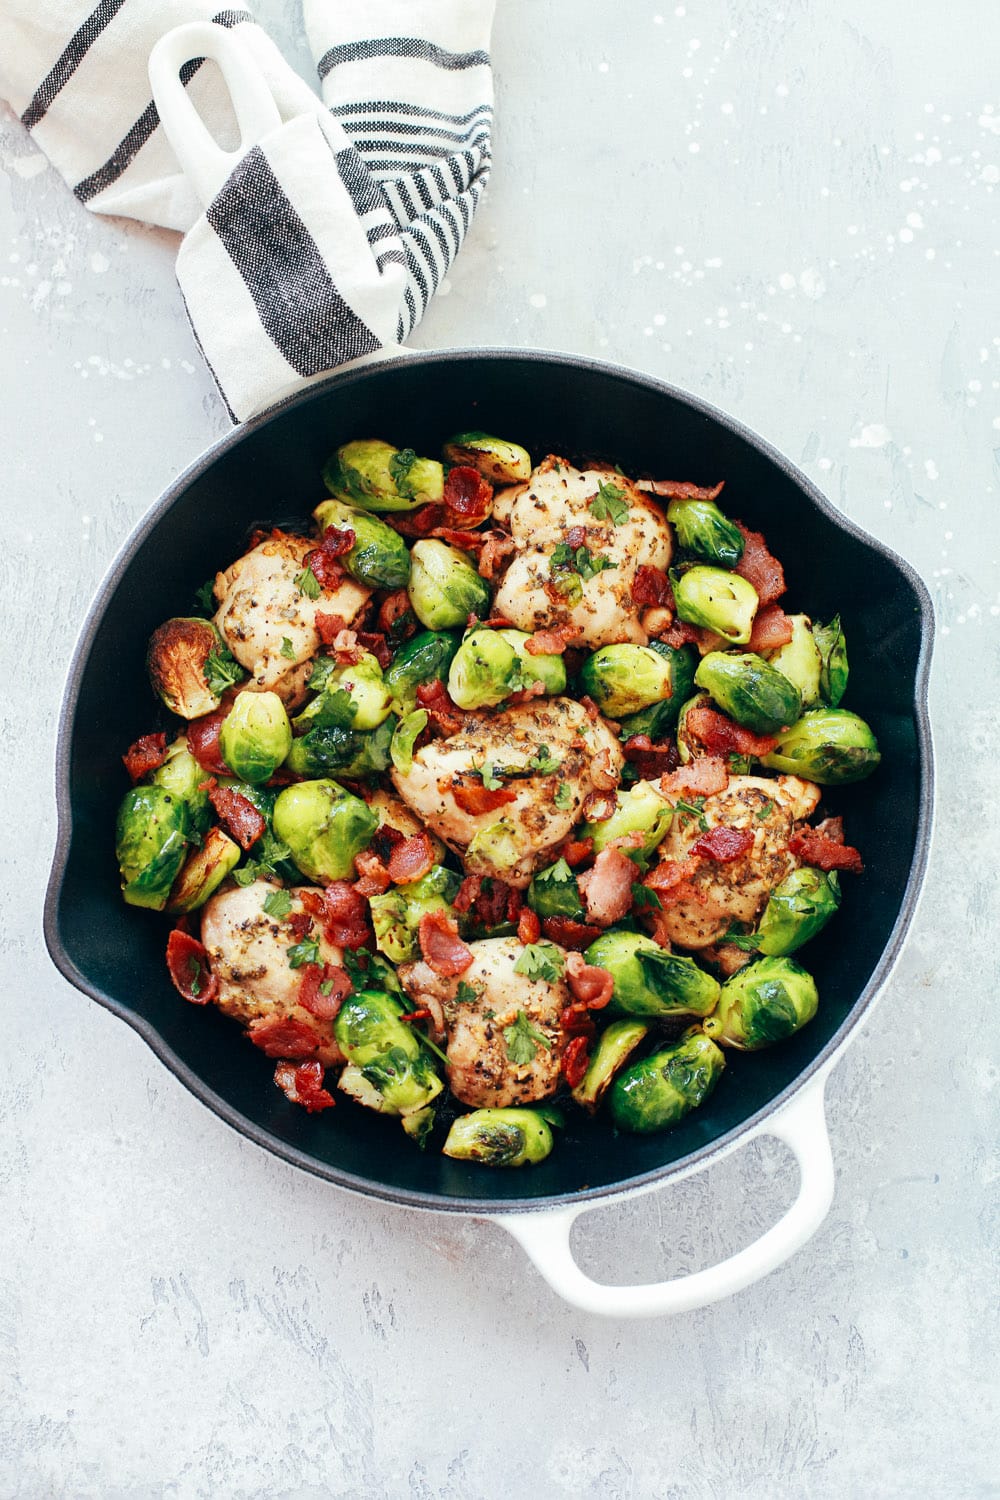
xmin=609 ymin=1031 xmax=726 ymax=1136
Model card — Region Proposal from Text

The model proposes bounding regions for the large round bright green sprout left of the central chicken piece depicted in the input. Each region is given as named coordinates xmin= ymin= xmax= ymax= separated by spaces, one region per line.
xmin=274 ymin=780 xmax=378 ymax=881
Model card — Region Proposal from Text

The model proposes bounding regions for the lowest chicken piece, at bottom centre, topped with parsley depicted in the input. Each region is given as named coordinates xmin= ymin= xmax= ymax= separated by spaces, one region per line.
xmin=399 ymin=938 xmax=573 ymax=1109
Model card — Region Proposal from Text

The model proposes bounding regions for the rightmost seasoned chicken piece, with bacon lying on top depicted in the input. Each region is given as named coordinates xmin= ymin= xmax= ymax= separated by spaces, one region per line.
xmin=655 ymin=776 xmax=820 ymax=948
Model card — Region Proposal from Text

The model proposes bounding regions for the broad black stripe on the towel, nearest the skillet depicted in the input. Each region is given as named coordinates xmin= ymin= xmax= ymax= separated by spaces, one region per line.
xmin=205 ymin=146 xmax=381 ymax=375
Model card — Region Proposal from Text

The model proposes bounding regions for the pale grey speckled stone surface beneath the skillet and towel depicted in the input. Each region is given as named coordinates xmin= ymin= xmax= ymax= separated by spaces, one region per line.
xmin=0 ymin=0 xmax=1000 ymax=1500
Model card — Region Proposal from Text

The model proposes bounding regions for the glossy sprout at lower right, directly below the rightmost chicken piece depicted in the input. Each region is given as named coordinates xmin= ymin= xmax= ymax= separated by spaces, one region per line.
xmin=705 ymin=959 xmax=819 ymax=1052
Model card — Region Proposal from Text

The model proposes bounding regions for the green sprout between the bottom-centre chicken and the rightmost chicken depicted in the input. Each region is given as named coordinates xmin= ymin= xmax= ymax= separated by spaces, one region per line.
xmin=583 ymin=932 xmax=720 ymax=1016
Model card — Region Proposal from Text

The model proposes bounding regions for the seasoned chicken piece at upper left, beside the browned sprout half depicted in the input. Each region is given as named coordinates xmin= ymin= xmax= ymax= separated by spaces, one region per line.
xmin=214 ymin=531 xmax=370 ymax=705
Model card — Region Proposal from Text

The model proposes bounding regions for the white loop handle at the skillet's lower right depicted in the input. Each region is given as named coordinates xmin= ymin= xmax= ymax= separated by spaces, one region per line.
xmin=492 ymin=1074 xmax=834 ymax=1317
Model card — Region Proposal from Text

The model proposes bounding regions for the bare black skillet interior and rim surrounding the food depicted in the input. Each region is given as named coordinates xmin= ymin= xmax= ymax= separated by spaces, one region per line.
xmin=46 ymin=351 xmax=933 ymax=1211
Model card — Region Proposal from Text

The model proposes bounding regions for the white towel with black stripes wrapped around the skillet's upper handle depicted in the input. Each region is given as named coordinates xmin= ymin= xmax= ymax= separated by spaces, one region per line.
xmin=0 ymin=0 xmax=493 ymax=420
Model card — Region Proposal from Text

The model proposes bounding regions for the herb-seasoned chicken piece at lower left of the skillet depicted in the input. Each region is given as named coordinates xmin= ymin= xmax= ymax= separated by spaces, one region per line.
xmin=201 ymin=881 xmax=343 ymax=1067
